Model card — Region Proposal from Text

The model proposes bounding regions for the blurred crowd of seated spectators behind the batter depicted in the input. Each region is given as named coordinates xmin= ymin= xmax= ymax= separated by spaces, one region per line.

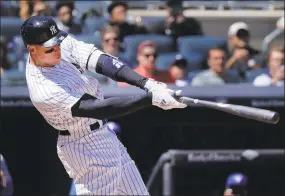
xmin=1 ymin=0 xmax=284 ymax=87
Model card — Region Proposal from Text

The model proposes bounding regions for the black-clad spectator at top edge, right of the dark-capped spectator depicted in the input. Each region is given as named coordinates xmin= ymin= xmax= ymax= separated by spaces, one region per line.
xmin=158 ymin=0 xmax=203 ymax=46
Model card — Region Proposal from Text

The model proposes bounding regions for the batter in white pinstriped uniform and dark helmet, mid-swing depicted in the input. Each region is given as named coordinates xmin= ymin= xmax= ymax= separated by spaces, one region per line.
xmin=21 ymin=16 xmax=186 ymax=195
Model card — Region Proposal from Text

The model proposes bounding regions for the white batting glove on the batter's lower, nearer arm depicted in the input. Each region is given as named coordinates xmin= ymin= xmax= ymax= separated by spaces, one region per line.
xmin=152 ymin=88 xmax=187 ymax=110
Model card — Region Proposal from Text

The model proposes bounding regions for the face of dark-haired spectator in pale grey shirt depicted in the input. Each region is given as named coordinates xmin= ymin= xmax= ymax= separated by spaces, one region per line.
xmin=208 ymin=50 xmax=225 ymax=73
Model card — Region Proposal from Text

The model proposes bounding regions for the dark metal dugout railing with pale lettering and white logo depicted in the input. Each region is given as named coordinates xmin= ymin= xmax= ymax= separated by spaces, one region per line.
xmin=147 ymin=149 xmax=284 ymax=196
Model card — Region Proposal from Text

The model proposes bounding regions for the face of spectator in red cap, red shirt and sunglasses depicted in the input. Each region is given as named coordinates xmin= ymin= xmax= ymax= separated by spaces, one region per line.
xmin=138 ymin=46 xmax=157 ymax=69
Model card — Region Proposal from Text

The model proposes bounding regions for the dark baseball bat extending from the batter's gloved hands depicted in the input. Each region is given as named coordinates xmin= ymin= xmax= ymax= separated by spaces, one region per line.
xmin=178 ymin=97 xmax=279 ymax=124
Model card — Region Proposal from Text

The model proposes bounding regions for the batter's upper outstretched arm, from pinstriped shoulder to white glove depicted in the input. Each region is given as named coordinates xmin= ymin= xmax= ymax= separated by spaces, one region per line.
xmin=61 ymin=36 xmax=164 ymax=92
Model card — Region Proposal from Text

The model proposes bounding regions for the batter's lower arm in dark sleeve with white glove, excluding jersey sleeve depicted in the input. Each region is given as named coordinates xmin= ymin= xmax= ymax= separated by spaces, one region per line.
xmin=71 ymin=89 xmax=186 ymax=120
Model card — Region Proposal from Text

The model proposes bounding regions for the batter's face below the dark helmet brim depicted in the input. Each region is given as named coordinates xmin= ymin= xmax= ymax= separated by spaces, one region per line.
xmin=30 ymin=44 xmax=61 ymax=66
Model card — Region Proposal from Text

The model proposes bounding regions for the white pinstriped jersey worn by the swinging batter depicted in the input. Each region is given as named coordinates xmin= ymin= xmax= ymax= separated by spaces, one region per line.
xmin=26 ymin=36 xmax=103 ymax=137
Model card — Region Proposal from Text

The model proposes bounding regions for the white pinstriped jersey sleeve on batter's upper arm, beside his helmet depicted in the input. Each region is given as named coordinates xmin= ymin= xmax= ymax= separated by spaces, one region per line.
xmin=61 ymin=35 xmax=105 ymax=72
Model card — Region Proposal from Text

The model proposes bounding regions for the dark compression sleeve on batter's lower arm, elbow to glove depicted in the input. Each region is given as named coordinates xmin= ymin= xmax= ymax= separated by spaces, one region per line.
xmin=71 ymin=93 xmax=152 ymax=120
